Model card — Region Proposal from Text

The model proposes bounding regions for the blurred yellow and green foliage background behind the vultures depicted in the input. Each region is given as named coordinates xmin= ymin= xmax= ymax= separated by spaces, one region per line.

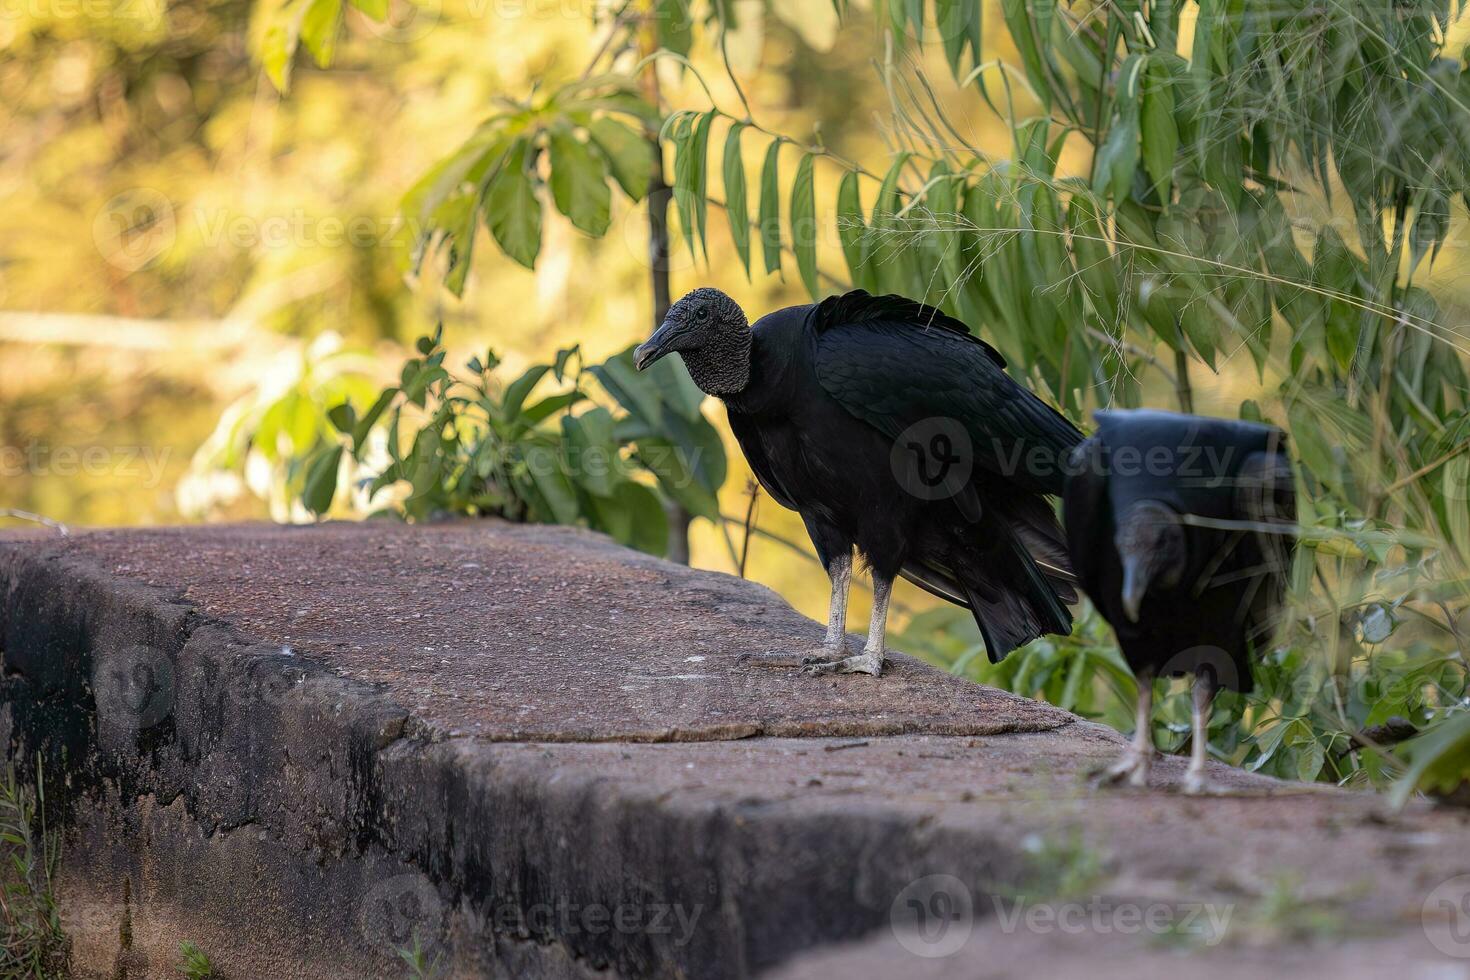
xmin=0 ymin=0 xmax=1470 ymax=789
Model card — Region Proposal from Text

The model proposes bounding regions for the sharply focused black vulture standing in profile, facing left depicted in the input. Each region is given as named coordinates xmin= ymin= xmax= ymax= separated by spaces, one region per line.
xmin=635 ymin=288 xmax=1082 ymax=674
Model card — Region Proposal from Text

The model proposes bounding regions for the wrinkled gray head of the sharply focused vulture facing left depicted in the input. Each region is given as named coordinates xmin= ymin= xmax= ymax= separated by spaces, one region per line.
xmin=634 ymin=287 xmax=751 ymax=395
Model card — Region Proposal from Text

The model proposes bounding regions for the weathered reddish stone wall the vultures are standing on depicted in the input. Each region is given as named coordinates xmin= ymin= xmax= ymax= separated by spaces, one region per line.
xmin=0 ymin=522 xmax=1470 ymax=980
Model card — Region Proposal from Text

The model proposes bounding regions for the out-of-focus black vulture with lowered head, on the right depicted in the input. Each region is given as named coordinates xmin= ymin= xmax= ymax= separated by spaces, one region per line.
xmin=1063 ymin=410 xmax=1297 ymax=793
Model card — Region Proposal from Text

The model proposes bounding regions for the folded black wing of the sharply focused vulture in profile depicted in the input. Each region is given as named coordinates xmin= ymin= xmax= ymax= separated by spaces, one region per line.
xmin=814 ymin=289 xmax=1082 ymax=494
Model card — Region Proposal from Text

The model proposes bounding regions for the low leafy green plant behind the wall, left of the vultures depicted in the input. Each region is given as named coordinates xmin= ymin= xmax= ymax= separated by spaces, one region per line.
xmin=196 ymin=329 xmax=726 ymax=554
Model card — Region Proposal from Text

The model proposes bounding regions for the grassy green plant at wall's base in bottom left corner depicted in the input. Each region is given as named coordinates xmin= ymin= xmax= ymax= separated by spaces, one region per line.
xmin=0 ymin=760 xmax=69 ymax=980
